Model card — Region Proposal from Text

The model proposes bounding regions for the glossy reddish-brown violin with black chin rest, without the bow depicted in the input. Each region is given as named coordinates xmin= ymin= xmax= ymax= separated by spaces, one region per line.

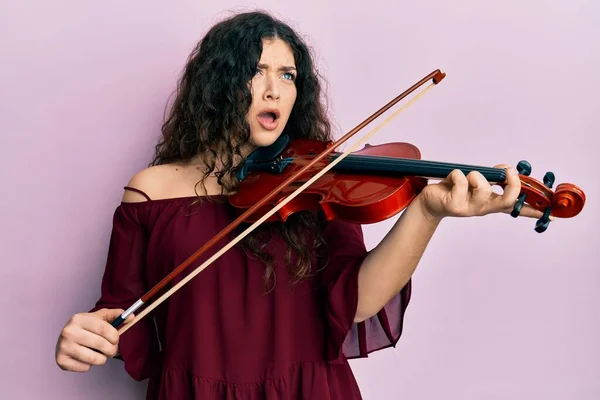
xmin=229 ymin=135 xmax=585 ymax=233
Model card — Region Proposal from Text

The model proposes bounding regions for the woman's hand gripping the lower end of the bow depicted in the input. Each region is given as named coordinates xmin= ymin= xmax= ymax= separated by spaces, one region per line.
xmin=55 ymin=308 xmax=134 ymax=372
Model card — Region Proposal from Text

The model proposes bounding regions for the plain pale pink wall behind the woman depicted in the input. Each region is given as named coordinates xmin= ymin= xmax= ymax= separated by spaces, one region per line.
xmin=0 ymin=0 xmax=600 ymax=400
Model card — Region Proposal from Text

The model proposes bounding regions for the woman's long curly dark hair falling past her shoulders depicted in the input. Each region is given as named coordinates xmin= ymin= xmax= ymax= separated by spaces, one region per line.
xmin=150 ymin=11 xmax=331 ymax=290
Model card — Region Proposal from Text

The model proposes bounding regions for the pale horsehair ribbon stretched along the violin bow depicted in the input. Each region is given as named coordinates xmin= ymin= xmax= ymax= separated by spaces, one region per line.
xmin=118 ymin=83 xmax=436 ymax=335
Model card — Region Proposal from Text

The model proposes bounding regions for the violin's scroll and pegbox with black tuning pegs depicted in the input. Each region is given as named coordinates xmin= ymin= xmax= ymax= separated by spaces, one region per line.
xmin=510 ymin=160 xmax=586 ymax=233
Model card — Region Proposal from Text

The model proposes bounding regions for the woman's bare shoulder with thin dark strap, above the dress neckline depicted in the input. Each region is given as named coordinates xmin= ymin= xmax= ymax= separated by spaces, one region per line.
xmin=122 ymin=164 xmax=185 ymax=203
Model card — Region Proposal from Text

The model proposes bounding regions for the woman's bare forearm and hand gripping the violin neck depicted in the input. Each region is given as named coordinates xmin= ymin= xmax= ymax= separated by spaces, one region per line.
xmin=355 ymin=166 xmax=542 ymax=322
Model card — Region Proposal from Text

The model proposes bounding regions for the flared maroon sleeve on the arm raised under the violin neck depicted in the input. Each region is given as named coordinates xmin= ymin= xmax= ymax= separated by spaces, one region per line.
xmin=321 ymin=220 xmax=411 ymax=361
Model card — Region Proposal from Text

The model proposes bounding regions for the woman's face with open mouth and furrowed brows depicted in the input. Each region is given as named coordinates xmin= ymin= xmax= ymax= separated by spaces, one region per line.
xmin=247 ymin=39 xmax=297 ymax=151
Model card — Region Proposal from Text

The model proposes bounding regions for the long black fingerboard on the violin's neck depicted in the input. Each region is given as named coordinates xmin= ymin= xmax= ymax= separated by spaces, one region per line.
xmin=331 ymin=154 xmax=506 ymax=183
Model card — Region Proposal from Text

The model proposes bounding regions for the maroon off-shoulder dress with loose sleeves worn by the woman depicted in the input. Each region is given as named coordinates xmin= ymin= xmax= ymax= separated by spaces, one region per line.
xmin=92 ymin=189 xmax=410 ymax=400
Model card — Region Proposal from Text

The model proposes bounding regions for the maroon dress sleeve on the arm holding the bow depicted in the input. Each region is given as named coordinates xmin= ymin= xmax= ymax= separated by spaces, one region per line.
xmin=90 ymin=203 xmax=159 ymax=381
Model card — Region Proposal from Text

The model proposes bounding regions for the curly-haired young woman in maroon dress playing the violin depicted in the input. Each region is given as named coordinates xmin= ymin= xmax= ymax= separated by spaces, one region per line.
xmin=56 ymin=13 xmax=539 ymax=400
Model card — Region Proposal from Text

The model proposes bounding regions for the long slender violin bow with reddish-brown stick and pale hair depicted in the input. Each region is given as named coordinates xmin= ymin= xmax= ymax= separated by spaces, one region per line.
xmin=111 ymin=69 xmax=446 ymax=335
